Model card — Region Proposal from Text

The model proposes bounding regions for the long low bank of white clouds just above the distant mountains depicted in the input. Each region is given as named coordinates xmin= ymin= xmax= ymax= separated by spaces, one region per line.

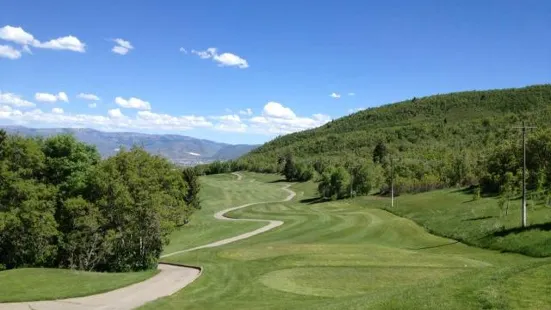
xmin=0 ymin=92 xmax=331 ymax=136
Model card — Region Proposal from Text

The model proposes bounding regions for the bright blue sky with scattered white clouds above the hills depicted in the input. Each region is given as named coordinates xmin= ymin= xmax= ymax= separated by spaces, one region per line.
xmin=0 ymin=0 xmax=551 ymax=143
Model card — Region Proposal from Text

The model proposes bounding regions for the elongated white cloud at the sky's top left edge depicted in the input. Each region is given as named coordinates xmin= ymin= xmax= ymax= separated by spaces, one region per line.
xmin=0 ymin=25 xmax=86 ymax=54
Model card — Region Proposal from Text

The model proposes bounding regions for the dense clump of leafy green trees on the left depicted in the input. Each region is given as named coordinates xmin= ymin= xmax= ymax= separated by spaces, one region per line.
xmin=0 ymin=130 xmax=200 ymax=272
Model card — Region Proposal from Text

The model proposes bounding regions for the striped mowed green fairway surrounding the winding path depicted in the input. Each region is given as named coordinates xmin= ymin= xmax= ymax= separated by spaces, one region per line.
xmin=144 ymin=173 xmax=551 ymax=309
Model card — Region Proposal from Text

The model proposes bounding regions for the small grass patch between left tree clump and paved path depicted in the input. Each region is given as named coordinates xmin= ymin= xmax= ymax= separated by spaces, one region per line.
xmin=0 ymin=268 xmax=157 ymax=302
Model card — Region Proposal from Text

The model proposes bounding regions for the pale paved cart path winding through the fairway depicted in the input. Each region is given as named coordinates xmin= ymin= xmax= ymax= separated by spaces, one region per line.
xmin=0 ymin=172 xmax=295 ymax=310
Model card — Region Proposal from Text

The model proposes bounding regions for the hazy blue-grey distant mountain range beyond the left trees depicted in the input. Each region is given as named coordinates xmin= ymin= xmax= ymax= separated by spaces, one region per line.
xmin=0 ymin=126 xmax=259 ymax=166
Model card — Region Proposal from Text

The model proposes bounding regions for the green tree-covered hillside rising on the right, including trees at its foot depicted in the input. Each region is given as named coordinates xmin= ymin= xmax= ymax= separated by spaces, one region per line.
xmin=207 ymin=84 xmax=551 ymax=197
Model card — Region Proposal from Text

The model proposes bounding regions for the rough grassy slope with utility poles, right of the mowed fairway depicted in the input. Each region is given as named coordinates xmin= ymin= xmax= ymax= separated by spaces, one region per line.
xmin=357 ymin=189 xmax=551 ymax=257
